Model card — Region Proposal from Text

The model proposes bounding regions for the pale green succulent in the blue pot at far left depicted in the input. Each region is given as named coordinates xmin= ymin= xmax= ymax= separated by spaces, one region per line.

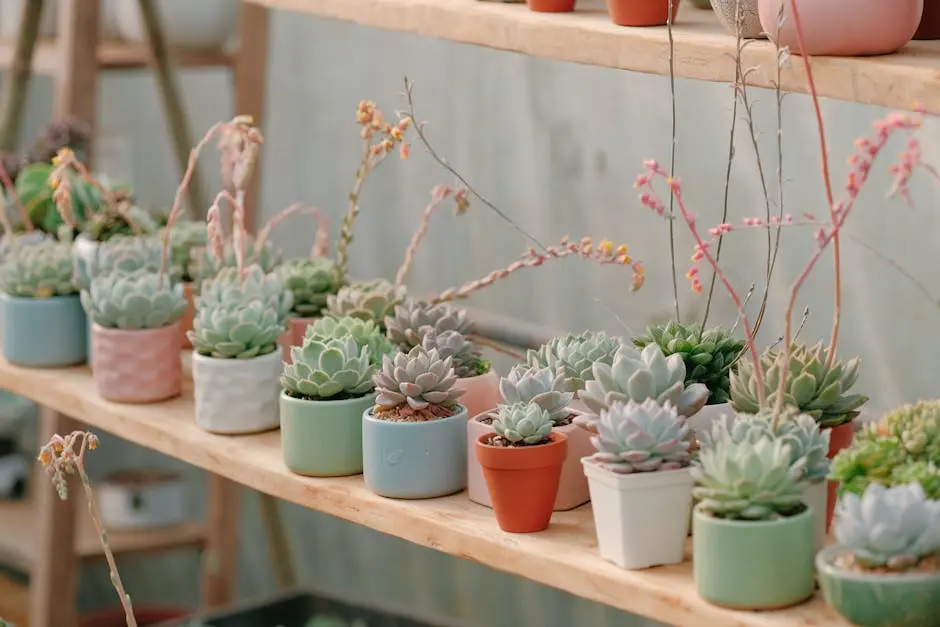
xmin=0 ymin=240 xmax=78 ymax=298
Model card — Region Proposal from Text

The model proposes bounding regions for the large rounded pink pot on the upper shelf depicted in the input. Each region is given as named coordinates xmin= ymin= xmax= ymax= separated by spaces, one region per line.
xmin=758 ymin=0 xmax=924 ymax=57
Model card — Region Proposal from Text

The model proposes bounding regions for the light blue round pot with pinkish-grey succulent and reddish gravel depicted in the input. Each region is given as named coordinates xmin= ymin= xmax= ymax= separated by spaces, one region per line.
xmin=362 ymin=346 xmax=467 ymax=499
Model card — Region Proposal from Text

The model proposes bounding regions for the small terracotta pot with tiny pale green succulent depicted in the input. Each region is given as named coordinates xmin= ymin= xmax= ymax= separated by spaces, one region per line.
xmin=476 ymin=403 xmax=568 ymax=533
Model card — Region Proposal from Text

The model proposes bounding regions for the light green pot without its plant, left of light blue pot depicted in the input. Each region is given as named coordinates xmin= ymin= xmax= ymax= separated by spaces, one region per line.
xmin=280 ymin=392 xmax=375 ymax=477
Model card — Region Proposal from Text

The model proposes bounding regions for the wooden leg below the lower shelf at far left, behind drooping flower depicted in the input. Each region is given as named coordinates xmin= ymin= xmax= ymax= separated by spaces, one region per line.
xmin=29 ymin=407 xmax=84 ymax=627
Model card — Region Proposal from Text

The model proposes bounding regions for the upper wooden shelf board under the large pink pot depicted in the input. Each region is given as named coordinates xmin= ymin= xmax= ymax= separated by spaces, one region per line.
xmin=249 ymin=0 xmax=940 ymax=114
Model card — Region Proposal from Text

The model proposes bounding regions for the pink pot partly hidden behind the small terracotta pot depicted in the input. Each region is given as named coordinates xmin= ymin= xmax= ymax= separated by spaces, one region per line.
xmin=467 ymin=406 xmax=596 ymax=512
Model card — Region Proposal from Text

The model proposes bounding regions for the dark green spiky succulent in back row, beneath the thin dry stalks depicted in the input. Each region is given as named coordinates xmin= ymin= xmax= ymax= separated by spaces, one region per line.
xmin=633 ymin=321 xmax=746 ymax=405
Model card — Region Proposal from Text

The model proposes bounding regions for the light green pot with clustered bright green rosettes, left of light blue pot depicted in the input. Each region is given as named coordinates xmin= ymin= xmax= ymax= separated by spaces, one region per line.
xmin=280 ymin=318 xmax=391 ymax=477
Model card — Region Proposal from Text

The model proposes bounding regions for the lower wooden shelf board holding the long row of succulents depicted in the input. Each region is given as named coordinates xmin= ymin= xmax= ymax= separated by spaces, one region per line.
xmin=0 ymin=359 xmax=846 ymax=627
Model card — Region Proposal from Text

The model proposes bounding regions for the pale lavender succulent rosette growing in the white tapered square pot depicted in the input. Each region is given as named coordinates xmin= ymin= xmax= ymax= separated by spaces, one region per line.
xmin=591 ymin=398 xmax=691 ymax=474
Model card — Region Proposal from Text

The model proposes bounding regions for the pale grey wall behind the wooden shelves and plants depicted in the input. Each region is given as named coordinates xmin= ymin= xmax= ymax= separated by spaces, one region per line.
xmin=9 ymin=7 xmax=940 ymax=627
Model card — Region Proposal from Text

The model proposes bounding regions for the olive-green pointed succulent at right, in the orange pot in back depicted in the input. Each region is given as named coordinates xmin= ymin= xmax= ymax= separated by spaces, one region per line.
xmin=731 ymin=342 xmax=868 ymax=427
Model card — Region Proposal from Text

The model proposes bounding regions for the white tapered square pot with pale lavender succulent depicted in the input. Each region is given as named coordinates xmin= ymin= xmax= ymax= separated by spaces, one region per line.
xmin=582 ymin=398 xmax=693 ymax=569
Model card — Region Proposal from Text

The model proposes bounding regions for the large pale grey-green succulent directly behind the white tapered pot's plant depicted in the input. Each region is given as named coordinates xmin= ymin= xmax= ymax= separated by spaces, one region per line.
xmin=576 ymin=344 xmax=708 ymax=431
